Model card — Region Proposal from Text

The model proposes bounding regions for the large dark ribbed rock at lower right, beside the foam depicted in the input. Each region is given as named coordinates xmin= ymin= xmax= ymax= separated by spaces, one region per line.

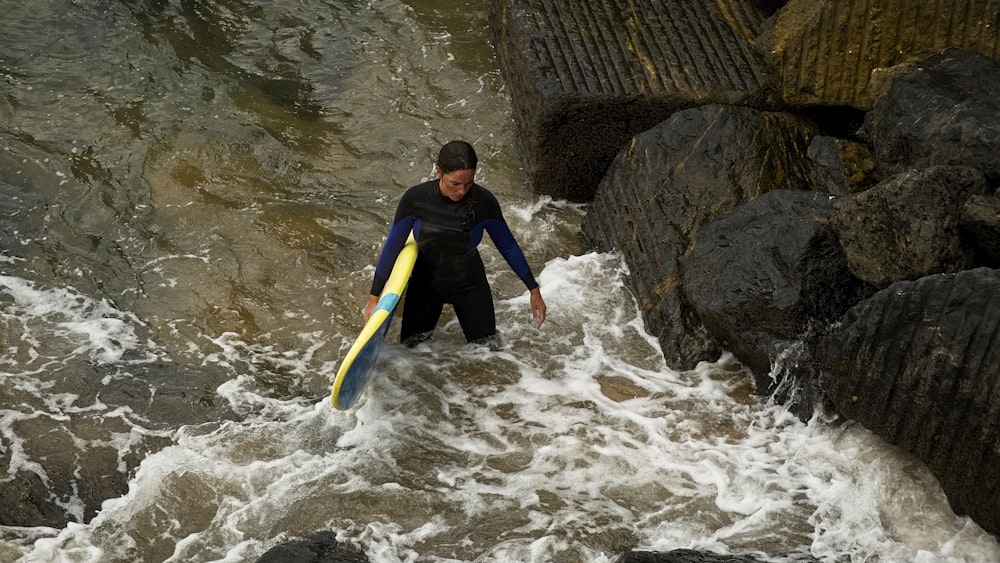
xmin=813 ymin=268 xmax=1000 ymax=534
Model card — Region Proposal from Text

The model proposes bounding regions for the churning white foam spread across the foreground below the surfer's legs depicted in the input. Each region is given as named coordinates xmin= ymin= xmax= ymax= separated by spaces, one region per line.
xmin=13 ymin=254 xmax=1000 ymax=562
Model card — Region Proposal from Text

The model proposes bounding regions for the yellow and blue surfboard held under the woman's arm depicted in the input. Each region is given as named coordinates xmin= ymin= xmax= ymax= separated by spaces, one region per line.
xmin=330 ymin=233 xmax=417 ymax=410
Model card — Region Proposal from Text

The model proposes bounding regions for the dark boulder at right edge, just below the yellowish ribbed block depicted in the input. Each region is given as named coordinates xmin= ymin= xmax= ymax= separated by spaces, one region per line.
xmin=860 ymin=49 xmax=1000 ymax=183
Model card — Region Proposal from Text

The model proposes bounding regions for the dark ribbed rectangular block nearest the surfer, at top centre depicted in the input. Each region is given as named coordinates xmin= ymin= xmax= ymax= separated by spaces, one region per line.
xmin=490 ymin=0 xmax=767 ymax=201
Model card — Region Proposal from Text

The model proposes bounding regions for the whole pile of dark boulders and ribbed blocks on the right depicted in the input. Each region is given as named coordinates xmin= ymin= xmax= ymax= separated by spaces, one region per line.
xmin=494 ymin=0 xmax=1000 ymax=533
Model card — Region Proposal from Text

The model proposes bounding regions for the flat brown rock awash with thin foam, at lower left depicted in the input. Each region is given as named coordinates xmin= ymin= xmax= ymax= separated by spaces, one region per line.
xmin=0 ymin=363 xmax=238 ymax=528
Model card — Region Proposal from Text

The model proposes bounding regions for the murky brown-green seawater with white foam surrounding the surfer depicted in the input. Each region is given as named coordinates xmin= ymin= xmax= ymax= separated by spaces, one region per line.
xmin=0 ymin=0 xmax=1000 ymax=562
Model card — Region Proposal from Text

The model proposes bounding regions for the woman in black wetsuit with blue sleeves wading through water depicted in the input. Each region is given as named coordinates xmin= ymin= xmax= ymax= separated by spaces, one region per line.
xmin=365 ymin=141 xmax=546 ymax=349
